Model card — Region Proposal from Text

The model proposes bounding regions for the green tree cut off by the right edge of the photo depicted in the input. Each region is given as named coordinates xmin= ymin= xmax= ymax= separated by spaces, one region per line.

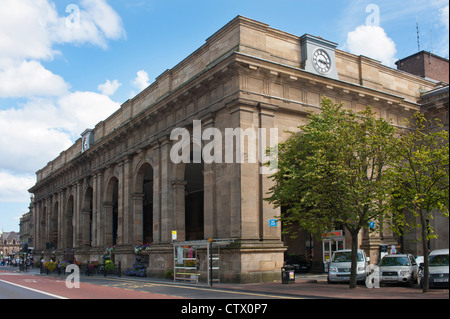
xmin=389 ymin=112 xmax=449 ymax=292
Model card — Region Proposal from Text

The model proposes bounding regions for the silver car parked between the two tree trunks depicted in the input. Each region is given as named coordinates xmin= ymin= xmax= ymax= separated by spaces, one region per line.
xmin=378 ymin=254 xmax=419 ymax=287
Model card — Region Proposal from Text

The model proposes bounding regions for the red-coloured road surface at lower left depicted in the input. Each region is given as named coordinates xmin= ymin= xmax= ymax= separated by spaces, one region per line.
xmin=0 ymin=270 xmax=181 ymax=299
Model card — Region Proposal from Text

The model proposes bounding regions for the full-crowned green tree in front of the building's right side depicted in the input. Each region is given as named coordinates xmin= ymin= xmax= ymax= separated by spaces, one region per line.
xmin=266 ymin=98 xmax=395 ymax=288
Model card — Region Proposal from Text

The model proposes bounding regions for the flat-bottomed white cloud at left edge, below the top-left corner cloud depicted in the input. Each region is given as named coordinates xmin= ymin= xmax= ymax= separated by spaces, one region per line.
xmin=0 ymin=61 xmax=69 ymax=98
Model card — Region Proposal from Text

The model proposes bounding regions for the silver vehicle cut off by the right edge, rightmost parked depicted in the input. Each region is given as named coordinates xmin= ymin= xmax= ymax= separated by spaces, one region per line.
xmin=420 ymin=249 xmax=449 ymax=288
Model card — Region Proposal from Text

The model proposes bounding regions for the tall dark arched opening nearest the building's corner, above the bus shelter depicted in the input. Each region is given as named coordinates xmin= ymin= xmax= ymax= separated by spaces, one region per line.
xmin=184 ymin=160 xmax=204 ymax=240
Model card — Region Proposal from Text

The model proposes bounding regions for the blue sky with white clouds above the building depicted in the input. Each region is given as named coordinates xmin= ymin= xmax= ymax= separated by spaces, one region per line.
xmin=0 ymin=0 xmax=449 ymax=231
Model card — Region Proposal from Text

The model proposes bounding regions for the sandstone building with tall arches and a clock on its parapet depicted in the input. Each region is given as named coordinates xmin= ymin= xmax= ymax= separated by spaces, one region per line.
xmin=30 ymin=16 xmax=446 ymax=282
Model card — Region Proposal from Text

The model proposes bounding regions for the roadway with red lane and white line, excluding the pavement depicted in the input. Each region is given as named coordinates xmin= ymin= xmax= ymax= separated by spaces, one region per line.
xmin=0 ymin=268 xmax=297 ymax=300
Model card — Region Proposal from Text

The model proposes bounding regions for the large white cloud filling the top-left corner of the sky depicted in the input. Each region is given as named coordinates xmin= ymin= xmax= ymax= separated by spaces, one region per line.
xmin=0 ymin=0 xmax=125 ymax=60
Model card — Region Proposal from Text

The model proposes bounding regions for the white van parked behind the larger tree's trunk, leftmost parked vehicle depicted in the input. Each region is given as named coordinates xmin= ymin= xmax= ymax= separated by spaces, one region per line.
xmin=327 ymin=249 xmax=370 ymax=283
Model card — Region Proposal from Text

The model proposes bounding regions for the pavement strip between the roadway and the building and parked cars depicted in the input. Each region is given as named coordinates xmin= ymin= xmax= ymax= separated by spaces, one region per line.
xmin=0 ymin=267 xmax=449 ymax=300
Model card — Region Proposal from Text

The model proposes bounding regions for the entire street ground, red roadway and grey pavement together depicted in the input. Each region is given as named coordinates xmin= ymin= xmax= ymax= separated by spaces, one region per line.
xmin=0 ymin=267 xmax=449 ymax=303
